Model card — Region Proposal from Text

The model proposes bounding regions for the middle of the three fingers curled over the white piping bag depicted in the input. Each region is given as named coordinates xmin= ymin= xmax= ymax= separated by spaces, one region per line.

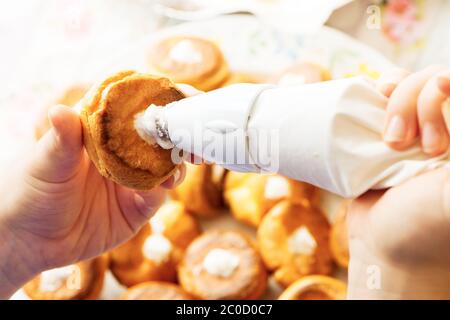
xmin=383 ymin=66 xmax=442 ymax=150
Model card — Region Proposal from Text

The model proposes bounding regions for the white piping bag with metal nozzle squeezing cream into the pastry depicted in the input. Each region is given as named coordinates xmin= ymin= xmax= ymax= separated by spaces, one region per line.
xmin=135 ymin=77 xmax=449 ymax=198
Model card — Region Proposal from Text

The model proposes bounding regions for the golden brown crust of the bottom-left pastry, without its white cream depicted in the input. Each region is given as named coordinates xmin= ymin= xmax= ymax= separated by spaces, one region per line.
xmin=24 ymin=255 xmax=109 ymax=300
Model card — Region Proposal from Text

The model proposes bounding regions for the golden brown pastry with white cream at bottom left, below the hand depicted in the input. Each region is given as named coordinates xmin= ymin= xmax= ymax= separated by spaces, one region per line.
xmin=24 ymin=255 xmax=108 ymax=300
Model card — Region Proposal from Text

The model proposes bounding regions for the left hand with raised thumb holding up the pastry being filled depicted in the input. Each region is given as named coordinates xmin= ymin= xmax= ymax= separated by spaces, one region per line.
xmin=0 ymin=86 xmax=198 ymax=299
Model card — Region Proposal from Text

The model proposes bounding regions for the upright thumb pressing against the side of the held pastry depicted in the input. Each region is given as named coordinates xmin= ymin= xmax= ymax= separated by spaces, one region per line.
xmin=29 ymin=106 xmax=83 ymax=183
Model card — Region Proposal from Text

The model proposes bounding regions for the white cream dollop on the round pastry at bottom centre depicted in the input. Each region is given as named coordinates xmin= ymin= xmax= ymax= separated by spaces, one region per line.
xmin=202 ymin=249 xmax=240 ymax=278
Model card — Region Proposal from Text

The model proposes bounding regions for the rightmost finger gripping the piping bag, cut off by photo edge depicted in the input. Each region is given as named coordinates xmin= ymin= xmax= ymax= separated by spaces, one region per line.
xmin=417 ymin=69 xmax=450 ymax=156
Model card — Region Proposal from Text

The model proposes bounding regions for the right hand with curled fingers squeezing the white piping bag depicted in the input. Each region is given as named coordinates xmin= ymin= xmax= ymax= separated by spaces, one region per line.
xmin=348 ymin=66 xmax=450 ymax=299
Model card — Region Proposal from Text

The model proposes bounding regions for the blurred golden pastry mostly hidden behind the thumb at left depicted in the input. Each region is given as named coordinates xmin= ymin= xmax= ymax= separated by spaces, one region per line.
xmin=34 ymin=85 xmax=88 ymax=140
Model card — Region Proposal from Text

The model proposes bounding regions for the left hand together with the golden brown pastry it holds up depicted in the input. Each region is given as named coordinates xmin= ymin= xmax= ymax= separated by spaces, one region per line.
xmin=0 ymin=72 xmax=183 ymax=298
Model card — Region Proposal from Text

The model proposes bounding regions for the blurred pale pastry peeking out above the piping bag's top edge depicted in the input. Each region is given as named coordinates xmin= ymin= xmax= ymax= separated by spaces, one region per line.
xmin=274 ymin=62 xmax=331 ymax=85
